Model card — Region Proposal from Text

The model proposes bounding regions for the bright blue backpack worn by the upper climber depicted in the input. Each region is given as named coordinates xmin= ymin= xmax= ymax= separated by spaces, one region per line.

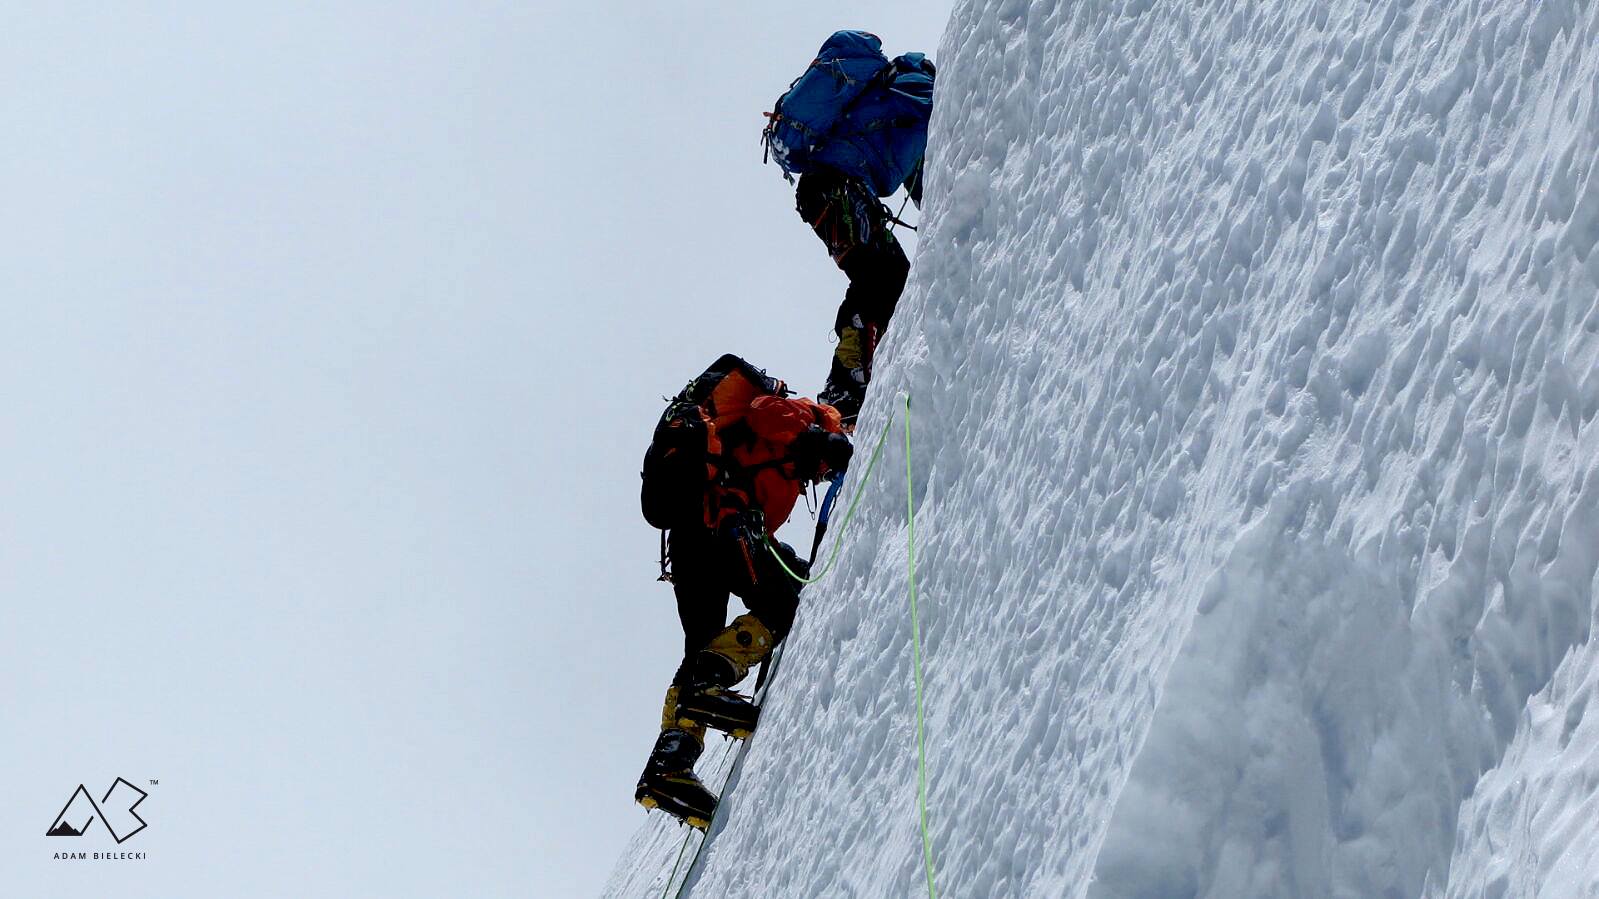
xmin=761 ymin=30 xmax=934 ymax=197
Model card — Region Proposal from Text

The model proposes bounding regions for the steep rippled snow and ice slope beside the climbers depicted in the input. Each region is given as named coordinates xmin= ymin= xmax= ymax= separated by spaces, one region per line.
xmin=606 ymin=0 xmax=1599 ymax=897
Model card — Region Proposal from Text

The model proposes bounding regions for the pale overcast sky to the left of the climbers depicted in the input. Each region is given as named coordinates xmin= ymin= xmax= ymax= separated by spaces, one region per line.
xmin=0 ymin=0 xmax=950 ymax=897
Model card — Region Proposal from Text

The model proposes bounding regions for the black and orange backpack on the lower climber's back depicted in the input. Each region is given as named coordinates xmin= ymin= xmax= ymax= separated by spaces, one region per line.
xmin=640 ymin=354 xmax=790 ymax=531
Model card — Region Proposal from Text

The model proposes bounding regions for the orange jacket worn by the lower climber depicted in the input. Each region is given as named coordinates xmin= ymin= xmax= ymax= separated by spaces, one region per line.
xmin=705 ymin=397 xmax=844 ymax=533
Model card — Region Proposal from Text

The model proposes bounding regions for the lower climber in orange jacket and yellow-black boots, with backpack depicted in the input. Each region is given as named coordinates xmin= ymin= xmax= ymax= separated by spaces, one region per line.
xmin=635 ymin=355 xmax=852 ymax=829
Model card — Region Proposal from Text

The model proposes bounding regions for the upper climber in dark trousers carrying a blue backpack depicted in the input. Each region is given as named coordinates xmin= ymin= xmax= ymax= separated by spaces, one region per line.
xmin=761 ymin=30 xmax=935 ymax=426
